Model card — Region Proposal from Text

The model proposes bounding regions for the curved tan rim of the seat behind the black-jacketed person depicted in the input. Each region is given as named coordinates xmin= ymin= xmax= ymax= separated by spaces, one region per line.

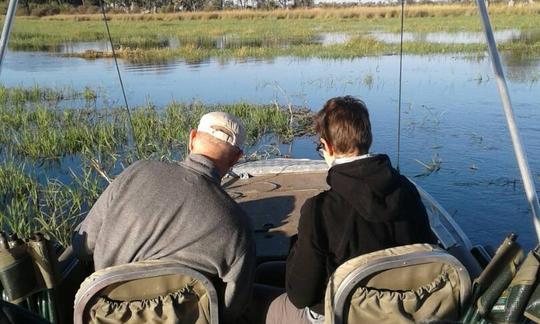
xmin=330 ymin=251 xmax=471 ymax=324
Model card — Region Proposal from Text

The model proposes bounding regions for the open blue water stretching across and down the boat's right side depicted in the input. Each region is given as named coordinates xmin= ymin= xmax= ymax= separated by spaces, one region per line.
xmin=2 ymin=44 xmax=540 ymax=248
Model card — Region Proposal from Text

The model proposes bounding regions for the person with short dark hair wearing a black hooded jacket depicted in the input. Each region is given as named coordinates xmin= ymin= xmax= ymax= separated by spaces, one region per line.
xmin=267 ymin=96 xmax=434 ymax=324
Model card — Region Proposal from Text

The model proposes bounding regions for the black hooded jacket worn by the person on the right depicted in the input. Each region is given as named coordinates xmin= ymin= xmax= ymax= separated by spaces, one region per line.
xmin=286 ymin=155 xmax=435 ymax=314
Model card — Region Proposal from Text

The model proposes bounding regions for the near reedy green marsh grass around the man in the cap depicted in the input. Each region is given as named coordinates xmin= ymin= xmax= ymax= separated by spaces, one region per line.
xmin=0 ymin=87 xmax=311 ymax=244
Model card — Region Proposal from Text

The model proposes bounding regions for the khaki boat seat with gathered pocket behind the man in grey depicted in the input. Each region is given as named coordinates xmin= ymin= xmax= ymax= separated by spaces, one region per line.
xmin=73 ymin=260 xmax=218 ymax=324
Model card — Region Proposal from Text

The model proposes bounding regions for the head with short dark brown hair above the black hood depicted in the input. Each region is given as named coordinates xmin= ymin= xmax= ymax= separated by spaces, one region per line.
xmin=315 ymin=96 xmax=373 ymax=154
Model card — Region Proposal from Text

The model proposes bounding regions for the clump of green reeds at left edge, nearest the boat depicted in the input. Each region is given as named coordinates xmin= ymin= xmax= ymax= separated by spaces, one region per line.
xmin=0 ymin=160 xmax=103 ymax=246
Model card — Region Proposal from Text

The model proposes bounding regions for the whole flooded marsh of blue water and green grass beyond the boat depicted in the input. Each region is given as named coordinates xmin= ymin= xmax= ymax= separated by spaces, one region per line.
xmin=0 ymin=4 xmax=540 ymax=252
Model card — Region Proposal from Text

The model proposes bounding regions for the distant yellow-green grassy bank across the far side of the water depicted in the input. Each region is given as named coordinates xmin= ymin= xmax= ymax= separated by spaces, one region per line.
xmin=10 ymin=4 xmax=540 ymax=61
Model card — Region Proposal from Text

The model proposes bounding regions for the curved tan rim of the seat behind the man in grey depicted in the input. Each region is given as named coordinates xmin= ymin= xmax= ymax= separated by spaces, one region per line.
xmin=73 ymin=260 xmax=219 ymax=324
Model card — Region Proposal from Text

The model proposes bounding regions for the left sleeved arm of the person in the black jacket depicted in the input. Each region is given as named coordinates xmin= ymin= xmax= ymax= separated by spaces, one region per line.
xmin=286 ymin=198 xmax=326 ymax=308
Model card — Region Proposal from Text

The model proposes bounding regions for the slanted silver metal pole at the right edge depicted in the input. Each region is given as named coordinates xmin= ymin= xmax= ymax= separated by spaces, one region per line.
xmin=476 ymin=0 xmax=540 ymax=240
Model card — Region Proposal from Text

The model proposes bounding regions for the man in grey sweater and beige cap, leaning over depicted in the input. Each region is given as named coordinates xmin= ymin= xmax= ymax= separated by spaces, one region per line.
xmin=73 ymin=112 xmax=255 ymax=323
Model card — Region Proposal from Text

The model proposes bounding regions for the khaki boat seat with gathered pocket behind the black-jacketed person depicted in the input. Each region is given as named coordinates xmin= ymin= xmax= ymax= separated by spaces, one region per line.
xmin=325 ymin=244 xmax=471 ymax=324
